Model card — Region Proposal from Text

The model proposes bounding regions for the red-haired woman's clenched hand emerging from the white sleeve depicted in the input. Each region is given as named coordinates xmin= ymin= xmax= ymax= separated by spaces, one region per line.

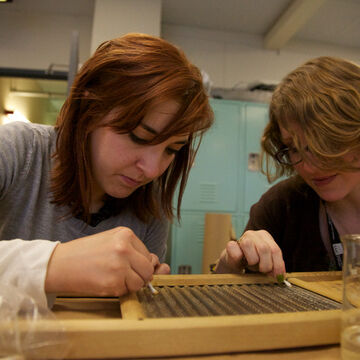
xmin=45 ymin=227 xmax=170 ymax=296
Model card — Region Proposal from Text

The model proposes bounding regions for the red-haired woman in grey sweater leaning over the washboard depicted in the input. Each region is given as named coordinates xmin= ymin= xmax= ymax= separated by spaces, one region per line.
xmin=0 ymin=34 xmax=213 ymax=304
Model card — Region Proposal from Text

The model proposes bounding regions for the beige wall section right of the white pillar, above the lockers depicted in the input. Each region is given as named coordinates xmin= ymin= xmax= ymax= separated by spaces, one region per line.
xmin=162 ymin=23 xmax=360 ymax=88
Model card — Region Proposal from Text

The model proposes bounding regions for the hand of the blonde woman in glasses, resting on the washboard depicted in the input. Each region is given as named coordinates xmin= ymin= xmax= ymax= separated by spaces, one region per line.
xmin=215 ymin=230 xmax=286 ymax=277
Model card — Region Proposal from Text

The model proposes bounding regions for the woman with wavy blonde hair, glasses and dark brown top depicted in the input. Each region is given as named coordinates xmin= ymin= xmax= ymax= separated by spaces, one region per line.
xmin=216 ymin=57 xmax=360 ymax=276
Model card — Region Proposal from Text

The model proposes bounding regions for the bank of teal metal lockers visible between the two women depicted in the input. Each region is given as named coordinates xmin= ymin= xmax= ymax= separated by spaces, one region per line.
xmin=171 ymin=99 xmax=268 ymax=273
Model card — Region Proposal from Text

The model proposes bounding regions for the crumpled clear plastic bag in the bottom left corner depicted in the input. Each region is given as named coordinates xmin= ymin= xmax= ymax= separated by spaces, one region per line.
xmin=0 ymin=284 xmax=69 ymax=360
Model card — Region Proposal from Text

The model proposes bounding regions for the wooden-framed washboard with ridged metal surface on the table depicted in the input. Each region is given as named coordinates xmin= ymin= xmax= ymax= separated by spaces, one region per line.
xmin=47 ymin=272 xmax=342 ymax=359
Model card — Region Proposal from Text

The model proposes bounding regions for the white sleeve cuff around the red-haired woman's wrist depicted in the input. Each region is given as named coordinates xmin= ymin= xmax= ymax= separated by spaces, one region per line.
xmin=0 ymin=239 xmax=59 ymax=307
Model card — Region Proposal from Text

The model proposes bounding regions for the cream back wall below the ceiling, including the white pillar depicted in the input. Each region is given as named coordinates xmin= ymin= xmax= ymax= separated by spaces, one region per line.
xmin=0 ymin=0 xmax=360 ymax=88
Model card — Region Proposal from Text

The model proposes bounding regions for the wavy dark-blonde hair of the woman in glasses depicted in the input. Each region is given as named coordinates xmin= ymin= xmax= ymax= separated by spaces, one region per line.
xmin=261 ymin=56 xmax=360 ymax=181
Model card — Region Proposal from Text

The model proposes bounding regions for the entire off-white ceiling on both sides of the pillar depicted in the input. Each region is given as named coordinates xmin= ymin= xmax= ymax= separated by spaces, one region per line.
xmin=4 ymin=0 xmax=360 ymax=48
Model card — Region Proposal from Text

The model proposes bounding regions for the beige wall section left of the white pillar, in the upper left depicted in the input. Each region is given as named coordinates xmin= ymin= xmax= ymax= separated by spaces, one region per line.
xmin=0 ymin=4 xmax=93 ymax=71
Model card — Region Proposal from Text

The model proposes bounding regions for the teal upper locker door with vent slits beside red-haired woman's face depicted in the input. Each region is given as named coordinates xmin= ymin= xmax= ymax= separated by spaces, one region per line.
xmin=178 ymin=101 xmax=241 ymax=212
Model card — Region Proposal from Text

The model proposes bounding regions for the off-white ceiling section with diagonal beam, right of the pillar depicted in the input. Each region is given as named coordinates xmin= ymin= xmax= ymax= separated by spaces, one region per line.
xmin=162 ymin=0 xmax=360 ymax=47
